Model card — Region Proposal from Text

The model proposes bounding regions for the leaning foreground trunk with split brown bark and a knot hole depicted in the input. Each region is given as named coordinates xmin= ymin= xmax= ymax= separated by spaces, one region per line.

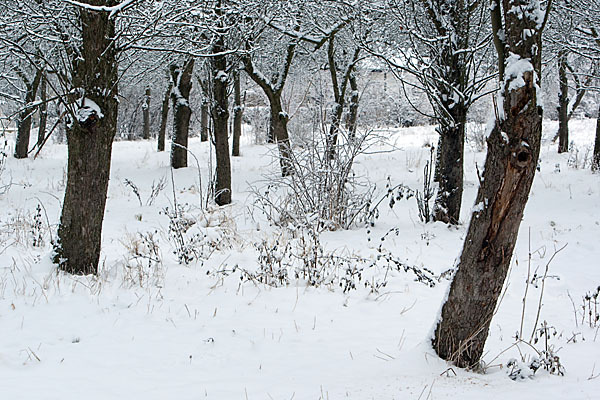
xmin=433 ymin=0 xmax=545 ymax=367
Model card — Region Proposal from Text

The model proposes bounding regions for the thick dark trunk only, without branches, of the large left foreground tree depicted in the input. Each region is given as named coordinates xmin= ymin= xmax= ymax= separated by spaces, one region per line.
xmin=54 ymin=1 xmax=118 ymax=274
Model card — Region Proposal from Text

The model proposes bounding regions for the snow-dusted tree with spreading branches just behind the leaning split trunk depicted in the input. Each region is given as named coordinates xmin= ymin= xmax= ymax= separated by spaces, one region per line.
xmin=370 ymin=0 xmax=493 ymax=224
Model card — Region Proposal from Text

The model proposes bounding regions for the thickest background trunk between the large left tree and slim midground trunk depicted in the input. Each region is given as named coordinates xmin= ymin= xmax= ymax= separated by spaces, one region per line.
xmin=171 ymin=57 xmax=194 ymax=169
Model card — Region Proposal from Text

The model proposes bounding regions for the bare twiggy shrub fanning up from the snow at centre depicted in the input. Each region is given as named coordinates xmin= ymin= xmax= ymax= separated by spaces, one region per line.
xmin=253 ymin=126 xmax=374 ymax=232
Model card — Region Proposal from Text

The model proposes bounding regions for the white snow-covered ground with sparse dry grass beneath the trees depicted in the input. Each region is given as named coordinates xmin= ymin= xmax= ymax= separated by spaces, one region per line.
xmin=0 ymin=120 xmax=600 ymax=400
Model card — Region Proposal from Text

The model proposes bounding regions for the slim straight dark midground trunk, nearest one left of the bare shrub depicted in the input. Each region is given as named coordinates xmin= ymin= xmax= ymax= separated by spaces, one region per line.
xmin=211 ymin=35 xmax=231 ymax=206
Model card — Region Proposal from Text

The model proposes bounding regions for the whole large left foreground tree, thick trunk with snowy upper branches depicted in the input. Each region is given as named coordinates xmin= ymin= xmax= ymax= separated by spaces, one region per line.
xmin=2 ymin=0 xmax=163 ymax=274
